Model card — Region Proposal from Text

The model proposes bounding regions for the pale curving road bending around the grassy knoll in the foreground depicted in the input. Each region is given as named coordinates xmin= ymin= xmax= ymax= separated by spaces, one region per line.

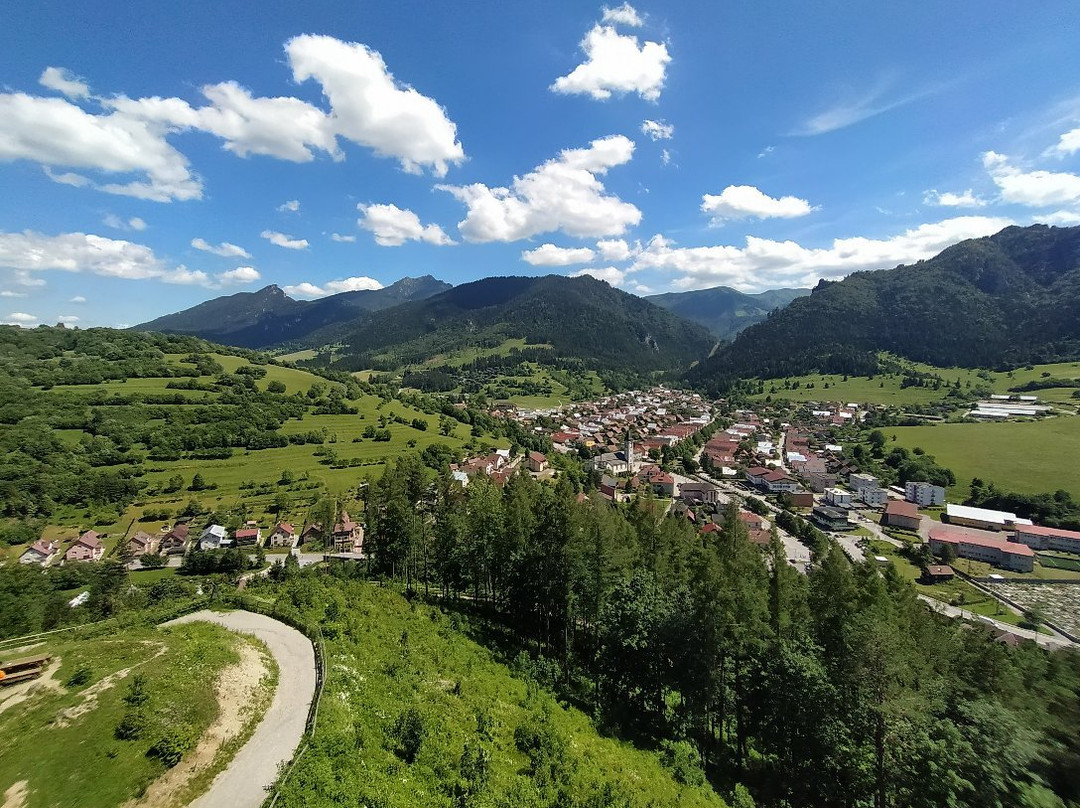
xmin=165 ymin=611 xmax=315 ymax=808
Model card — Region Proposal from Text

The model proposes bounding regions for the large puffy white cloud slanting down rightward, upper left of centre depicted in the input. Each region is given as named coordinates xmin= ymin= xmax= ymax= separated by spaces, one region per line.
xmin=285 ymin=35 xmax=465 ymax=177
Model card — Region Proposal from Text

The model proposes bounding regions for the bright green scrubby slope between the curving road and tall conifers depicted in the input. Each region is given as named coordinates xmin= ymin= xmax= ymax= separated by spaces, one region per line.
xmin=258 ymin=578 xmax=725 ymax=808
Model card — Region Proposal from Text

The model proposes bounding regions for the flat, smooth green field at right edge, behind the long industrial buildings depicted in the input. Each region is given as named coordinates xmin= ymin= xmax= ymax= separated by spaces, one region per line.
xmin=887 ymin=416 xmax=1080 ymax=501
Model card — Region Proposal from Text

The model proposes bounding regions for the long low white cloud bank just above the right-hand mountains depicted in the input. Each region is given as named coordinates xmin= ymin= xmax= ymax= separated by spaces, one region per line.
xmin=631 ymin=216 xmax=1013 ymax=292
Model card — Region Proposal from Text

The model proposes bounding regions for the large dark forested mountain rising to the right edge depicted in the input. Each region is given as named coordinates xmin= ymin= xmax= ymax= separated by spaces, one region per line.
xmin=690 ymin=225 xmax=1080 ymax=388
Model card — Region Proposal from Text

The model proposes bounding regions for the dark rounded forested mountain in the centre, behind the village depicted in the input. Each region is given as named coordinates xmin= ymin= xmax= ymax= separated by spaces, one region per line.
xmin=317 ymin=275 xmax=715 ymax=372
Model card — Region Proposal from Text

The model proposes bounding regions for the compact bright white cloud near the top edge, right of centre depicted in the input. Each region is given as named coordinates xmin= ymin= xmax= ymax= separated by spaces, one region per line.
xmin=551 ymin=18 xmax=672 ymax=100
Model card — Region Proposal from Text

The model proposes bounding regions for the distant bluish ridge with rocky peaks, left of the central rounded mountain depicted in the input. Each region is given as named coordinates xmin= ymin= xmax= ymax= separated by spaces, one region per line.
xmin=135 ymin=275 xmax=450 ymax=348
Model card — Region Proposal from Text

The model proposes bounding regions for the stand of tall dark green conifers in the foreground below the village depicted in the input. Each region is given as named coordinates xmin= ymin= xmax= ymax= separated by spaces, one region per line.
xmin=347 ymin=457 xmax=1080 ymax=808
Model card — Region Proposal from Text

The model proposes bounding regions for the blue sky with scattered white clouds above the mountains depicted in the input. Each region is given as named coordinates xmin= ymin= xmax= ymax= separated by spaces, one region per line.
xmin=0 ymin=0 xmax=1080 ymax=326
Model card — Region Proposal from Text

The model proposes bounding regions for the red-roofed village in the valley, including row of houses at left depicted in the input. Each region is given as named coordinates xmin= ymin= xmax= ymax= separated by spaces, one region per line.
xmin=10 ymin=387 xmax=1080 ymax=643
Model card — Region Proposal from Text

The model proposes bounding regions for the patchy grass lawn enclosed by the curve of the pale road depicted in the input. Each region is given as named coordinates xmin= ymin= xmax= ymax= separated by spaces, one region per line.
xmin=0 ymin=624 xmax=266 ymax=808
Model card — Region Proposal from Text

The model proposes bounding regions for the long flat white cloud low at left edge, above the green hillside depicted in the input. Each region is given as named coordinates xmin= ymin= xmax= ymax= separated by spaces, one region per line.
xmin=0 ymin=230 xmax=210 ymax=285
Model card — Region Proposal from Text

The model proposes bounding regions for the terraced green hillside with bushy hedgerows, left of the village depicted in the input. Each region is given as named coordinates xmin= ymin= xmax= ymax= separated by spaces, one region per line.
xmin=0 ymin=326 xmax=510 ymax=557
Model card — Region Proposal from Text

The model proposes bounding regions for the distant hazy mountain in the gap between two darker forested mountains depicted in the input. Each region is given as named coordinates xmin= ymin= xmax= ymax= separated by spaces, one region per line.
xmin=645 ymin=286 xmax=810 ymax=339
